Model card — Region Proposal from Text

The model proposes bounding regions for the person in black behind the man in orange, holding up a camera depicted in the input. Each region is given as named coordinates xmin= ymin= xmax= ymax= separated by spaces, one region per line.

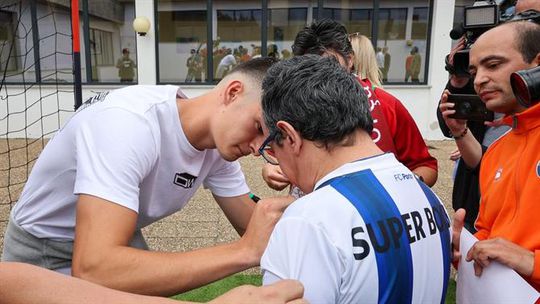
xmin=437 ymin=0 xmax=540 ymax=233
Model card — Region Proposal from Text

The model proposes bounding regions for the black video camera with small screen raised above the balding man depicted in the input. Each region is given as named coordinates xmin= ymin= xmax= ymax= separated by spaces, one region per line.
xmin=446 ymin=0 xmax=516 ymax=76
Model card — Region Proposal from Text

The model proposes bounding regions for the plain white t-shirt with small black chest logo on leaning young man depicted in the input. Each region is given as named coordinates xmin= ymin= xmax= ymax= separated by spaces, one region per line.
xmin=12 ymin=85 xmax=249 ymax=240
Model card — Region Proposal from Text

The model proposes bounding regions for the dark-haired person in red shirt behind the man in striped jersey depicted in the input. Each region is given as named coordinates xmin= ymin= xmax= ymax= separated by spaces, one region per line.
xmin=262 ymin=19 xmax=437 ymax=194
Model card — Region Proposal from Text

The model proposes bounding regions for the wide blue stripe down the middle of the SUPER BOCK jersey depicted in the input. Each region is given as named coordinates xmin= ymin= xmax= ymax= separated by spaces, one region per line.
xmin=329 ymin=170 xmax=413 ymax=303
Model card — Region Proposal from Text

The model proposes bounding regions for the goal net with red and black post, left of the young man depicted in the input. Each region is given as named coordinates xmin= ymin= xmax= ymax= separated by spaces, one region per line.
xmin=0 ymin=0 xmax=82 ymax=209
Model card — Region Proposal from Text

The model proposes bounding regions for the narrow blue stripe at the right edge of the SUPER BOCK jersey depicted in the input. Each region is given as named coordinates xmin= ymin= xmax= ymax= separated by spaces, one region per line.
xmin=418 ymin=181 xmax=452 ymax=304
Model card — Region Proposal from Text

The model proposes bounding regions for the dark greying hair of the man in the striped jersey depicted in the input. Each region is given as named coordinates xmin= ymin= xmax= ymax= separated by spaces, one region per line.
xmin=262 ymin=55 xmax=373 ymax=149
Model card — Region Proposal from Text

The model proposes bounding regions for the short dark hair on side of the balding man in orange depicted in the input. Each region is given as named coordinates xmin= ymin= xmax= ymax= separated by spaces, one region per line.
xmin=509 ymin=21 xmax=540 ymax=63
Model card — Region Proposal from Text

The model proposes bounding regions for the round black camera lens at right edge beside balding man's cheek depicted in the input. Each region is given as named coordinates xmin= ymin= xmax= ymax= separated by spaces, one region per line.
xmin=510 ymin=66 xmax=540 ymax=108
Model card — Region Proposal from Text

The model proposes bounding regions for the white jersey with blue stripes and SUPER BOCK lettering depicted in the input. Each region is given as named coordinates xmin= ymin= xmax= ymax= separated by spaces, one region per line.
xmin=261 ymin=153 xmax=450 ymax=304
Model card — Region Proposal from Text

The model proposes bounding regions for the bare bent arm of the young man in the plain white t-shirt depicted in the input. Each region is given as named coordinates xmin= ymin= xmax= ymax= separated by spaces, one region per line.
xmin=72 ymin=195 xmax=259 ymax=296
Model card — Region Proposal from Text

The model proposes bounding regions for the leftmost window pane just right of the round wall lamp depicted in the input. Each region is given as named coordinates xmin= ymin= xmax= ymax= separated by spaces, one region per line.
xmin=156 ymin=0 xmax=208 ymax=83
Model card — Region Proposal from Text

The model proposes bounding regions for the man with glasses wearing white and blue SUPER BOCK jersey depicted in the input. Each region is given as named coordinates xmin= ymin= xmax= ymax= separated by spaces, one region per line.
xmin=259 ymin=55 xmax=451 ymax=303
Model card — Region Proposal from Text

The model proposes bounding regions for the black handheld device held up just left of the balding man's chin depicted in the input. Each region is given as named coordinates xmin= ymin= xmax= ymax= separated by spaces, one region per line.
xmin=448 ymin=94 xmax=495 ymax=121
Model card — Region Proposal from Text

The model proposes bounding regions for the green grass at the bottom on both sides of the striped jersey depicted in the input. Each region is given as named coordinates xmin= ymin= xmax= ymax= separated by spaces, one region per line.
xmin=173 ymin=275 xmax=456 ymax=304
